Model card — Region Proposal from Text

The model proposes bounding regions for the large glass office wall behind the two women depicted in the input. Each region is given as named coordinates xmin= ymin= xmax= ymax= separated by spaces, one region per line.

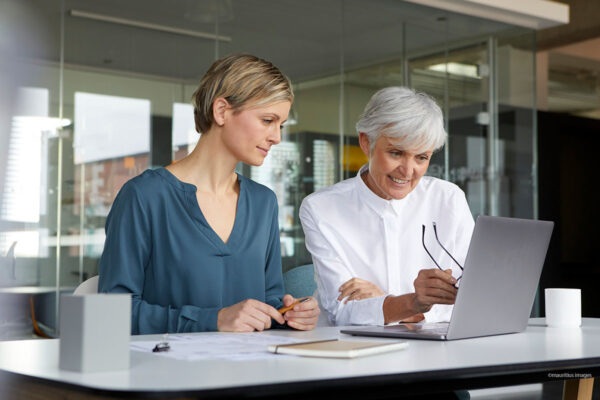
xmin=0 ymin=0 xmax=536 ymax=336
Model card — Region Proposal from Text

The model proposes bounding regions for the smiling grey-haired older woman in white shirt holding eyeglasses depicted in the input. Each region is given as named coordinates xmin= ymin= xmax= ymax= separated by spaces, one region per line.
xmin=300 ymin=87 xmax=474 ymax=325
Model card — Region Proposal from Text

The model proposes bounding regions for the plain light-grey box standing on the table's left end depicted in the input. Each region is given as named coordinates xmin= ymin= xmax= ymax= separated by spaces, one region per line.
xmin=59 ymin=294 xmax=131 ymax=372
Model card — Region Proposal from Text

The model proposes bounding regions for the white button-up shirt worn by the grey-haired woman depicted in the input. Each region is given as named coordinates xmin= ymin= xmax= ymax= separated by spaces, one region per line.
xmin=300 ymin=165 xmax=474 ymax=325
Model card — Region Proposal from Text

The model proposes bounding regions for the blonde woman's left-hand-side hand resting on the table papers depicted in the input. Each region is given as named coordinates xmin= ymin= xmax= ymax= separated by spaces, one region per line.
xmin=217 ymin=296 xmax=286 ymax=332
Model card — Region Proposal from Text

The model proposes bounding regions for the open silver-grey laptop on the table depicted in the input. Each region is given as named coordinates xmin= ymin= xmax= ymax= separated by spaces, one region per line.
xmin=341 ymin=215 xmax=554 ymax=340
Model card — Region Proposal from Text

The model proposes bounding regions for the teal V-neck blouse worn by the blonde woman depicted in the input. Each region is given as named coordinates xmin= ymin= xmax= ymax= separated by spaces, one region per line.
xmin=98 ymin=168 xmax=284 ymax=334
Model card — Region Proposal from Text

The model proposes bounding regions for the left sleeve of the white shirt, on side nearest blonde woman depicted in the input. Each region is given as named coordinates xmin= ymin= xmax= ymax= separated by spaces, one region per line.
xmin=300 ymin=200 xmax=385 ymax=325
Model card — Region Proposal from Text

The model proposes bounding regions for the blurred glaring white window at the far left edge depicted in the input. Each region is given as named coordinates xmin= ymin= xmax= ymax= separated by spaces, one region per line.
xmin=0 ymin=87 xmax=60 ymax=287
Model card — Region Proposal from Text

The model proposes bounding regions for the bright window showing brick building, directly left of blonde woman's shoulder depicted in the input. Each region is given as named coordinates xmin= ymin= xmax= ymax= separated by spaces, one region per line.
xmin=69 ymin=92 xmax=151 ymax=285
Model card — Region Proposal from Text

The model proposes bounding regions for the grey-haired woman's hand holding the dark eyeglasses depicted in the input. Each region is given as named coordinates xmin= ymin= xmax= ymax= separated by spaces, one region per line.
xmin=413 ymin=268 xmax=457 ymax=313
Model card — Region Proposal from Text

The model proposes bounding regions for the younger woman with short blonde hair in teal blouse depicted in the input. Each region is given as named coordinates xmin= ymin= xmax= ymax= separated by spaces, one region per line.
xmin=99 ymin=55 xmax=319 ymax=334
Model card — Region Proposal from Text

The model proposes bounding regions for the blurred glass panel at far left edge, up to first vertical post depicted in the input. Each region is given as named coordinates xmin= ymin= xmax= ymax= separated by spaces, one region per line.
xmin=0 ymin=1 xmax=64 ymax=339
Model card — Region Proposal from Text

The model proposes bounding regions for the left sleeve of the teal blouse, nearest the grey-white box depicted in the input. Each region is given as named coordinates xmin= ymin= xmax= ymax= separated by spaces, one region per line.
xmin=98 ymin=181 xmax=219 ymax=335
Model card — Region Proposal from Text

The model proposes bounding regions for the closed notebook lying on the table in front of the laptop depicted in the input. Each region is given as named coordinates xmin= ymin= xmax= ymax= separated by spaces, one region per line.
xmin=268 ymin=339 xmax=408 ymax=358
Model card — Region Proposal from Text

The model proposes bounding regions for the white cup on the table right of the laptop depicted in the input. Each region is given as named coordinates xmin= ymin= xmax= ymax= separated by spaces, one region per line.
xmin=544 ymin=289 xmax=581 ymax=328
